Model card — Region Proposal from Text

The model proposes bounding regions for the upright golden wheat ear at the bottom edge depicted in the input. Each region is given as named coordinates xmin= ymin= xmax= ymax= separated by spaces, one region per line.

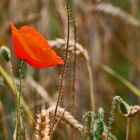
xmin=35 ymin=109 xmax=50 ymax=140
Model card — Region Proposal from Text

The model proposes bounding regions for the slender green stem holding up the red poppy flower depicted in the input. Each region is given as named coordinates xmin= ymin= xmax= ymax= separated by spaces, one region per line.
xmin=17 ymin=60 xmax=24 ymax=140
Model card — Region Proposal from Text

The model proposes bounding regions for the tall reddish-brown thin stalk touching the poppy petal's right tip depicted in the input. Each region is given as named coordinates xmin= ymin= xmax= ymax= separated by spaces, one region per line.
xmin=51 ymin=5 xmax=70 ymax=136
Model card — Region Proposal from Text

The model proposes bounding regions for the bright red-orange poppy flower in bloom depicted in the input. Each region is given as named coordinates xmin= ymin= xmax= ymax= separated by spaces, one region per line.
xmin=11 ymin=23 xmax=64 ymax=68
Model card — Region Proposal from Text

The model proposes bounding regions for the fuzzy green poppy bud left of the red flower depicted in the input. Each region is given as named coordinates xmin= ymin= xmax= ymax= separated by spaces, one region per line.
xmin=0 ymin=46 xmax=11 ymax=62
